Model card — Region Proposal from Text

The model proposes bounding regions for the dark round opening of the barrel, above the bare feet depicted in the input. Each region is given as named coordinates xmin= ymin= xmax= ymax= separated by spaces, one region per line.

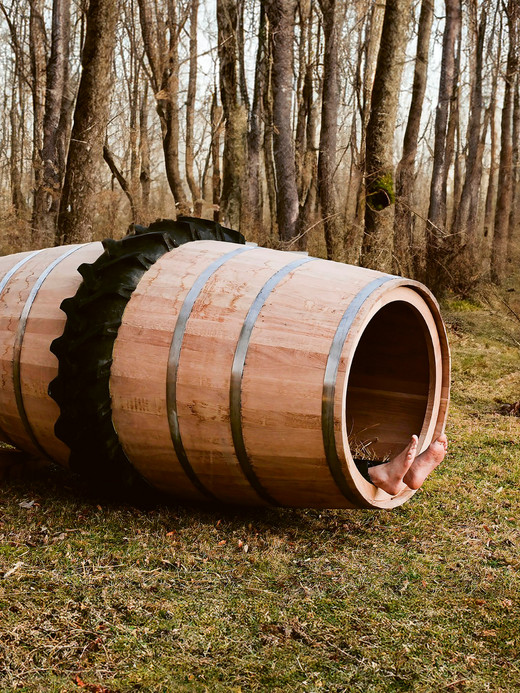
xmin=345 ymin=301 xmax=434 ymax=468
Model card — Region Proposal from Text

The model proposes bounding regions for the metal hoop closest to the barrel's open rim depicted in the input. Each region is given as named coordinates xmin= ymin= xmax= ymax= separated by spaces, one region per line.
xmin=321 ymin=275 xmax=397 ymax=503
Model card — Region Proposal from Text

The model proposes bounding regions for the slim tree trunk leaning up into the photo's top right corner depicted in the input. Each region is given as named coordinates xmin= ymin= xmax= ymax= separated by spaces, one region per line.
xmin=491 ymin=0 xmax=518 ymax=284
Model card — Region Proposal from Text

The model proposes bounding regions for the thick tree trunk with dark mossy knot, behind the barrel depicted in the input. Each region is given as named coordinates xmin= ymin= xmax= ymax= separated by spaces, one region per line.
xmin=361 ymin=0 xmax=410 ymax=271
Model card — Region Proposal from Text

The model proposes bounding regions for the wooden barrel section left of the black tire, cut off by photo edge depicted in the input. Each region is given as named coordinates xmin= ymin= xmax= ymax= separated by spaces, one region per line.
xmin=0 ymin=243 xmax=103 ymax=464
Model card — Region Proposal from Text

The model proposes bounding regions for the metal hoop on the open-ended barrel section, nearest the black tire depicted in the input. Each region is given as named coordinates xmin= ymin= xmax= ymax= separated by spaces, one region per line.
xmin=166 ymin=246 xmax=255 ymax=500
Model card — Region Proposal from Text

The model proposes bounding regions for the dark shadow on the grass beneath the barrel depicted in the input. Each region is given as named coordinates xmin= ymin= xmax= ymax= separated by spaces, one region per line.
xmin=0 ymin=454 xmax=390 ymax=545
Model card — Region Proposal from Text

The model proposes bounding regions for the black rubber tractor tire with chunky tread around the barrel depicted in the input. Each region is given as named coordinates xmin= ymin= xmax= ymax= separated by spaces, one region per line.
xmin=49 ymin=217 xmax=245 ymax=503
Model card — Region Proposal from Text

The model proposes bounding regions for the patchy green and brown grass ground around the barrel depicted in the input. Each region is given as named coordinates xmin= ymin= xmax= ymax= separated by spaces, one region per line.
xmin=0 ymin=294 xmax=520 ymax=693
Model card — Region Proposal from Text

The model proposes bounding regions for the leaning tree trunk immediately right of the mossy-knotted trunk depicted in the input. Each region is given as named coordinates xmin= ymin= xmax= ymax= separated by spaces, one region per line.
xmin=394 ymin=0 xmax=433 ymax=277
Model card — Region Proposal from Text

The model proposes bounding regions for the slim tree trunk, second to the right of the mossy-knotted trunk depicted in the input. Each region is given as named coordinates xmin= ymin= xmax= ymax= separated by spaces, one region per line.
xmin=426 ymin=0 xmax=461 ymax=288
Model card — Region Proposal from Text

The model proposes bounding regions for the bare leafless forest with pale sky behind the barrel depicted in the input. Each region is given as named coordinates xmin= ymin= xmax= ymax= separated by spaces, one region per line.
xmin=0 ymin=0 xmax=520 ymax=296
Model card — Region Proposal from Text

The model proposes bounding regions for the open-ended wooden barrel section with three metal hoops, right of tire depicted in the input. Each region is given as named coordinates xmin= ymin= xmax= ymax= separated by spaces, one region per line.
xmin=110 ymin=241 xmax=450 ymax=508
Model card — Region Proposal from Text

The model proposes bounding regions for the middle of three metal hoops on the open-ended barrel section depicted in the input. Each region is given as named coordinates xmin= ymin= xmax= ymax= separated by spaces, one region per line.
xmin=229 ymin=257 xmax=316 ymax=505
